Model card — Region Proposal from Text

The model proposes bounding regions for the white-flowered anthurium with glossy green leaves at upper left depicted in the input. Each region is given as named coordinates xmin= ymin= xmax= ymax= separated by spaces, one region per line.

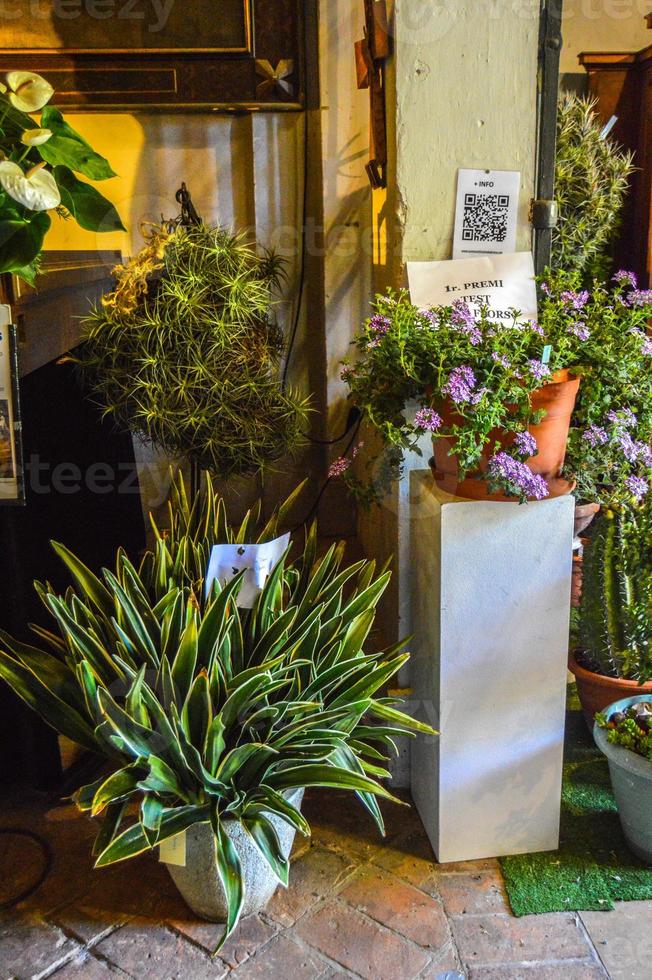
xmin=0 ymin=71 xmax=124 ymax=284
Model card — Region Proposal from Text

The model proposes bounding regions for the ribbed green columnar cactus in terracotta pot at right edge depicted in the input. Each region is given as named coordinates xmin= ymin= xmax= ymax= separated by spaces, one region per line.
xmin=580 ymin=500 xmax=652 ymax=684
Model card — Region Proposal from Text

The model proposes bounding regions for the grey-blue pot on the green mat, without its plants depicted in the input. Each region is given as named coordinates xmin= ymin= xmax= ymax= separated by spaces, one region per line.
xmin=593 ymin=695 xmax=652 ymax=864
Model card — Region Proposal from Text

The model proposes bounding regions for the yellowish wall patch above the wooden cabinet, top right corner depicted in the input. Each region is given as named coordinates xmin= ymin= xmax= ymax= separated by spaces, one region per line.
xmin=561 ymin=0 xmax=652 ymax=72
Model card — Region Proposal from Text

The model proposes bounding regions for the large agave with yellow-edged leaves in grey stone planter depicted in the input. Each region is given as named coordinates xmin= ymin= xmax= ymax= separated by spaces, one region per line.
xmin=0 ymin=481 xmax=432 ymax=941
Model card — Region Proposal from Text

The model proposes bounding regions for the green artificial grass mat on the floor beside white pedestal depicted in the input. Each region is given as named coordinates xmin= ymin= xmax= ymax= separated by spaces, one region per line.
xmin=500 ymin=685 xmax=652 ymax=916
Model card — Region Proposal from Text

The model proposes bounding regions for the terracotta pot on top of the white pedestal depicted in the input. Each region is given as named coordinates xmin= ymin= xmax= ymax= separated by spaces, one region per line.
xmin=431 ymin=370 xmax=580 ymax=502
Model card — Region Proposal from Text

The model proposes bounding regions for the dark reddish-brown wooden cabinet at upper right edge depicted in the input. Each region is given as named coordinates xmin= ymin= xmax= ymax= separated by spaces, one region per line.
xmin=580 ymin=45 xmax=652 ymax=287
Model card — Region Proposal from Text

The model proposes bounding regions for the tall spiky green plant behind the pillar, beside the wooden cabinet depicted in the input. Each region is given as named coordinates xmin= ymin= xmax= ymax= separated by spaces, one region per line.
xmin=551 ymin=93 xmax=634 ymax=279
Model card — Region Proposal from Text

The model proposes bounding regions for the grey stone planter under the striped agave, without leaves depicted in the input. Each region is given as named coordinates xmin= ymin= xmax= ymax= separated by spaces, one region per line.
xmin=163 ymin=789 xmax=304 ymax=922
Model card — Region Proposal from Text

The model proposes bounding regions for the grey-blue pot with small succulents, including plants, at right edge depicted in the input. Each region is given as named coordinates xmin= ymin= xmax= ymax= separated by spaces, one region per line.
xmin=594 ymin=694 xmax=652 ymax=864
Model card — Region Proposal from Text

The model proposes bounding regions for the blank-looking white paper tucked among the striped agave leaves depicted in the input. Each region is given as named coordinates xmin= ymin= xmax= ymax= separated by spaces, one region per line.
xmin=206 ymin=534 xmax=290 ymax=609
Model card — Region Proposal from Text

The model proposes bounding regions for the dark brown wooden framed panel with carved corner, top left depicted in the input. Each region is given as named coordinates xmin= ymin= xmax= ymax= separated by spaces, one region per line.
xmin=0 ymin=0 xmax=304 ymax=110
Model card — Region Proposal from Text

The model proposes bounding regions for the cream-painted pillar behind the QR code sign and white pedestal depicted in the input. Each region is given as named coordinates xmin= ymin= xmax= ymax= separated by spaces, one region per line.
xmin=359 ymin=0 xmax=539 ymax=652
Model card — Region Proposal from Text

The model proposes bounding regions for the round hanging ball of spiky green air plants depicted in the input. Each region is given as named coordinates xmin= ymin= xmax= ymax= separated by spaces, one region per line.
xmin=82 ymin=226 xmax=308 ymax=477
